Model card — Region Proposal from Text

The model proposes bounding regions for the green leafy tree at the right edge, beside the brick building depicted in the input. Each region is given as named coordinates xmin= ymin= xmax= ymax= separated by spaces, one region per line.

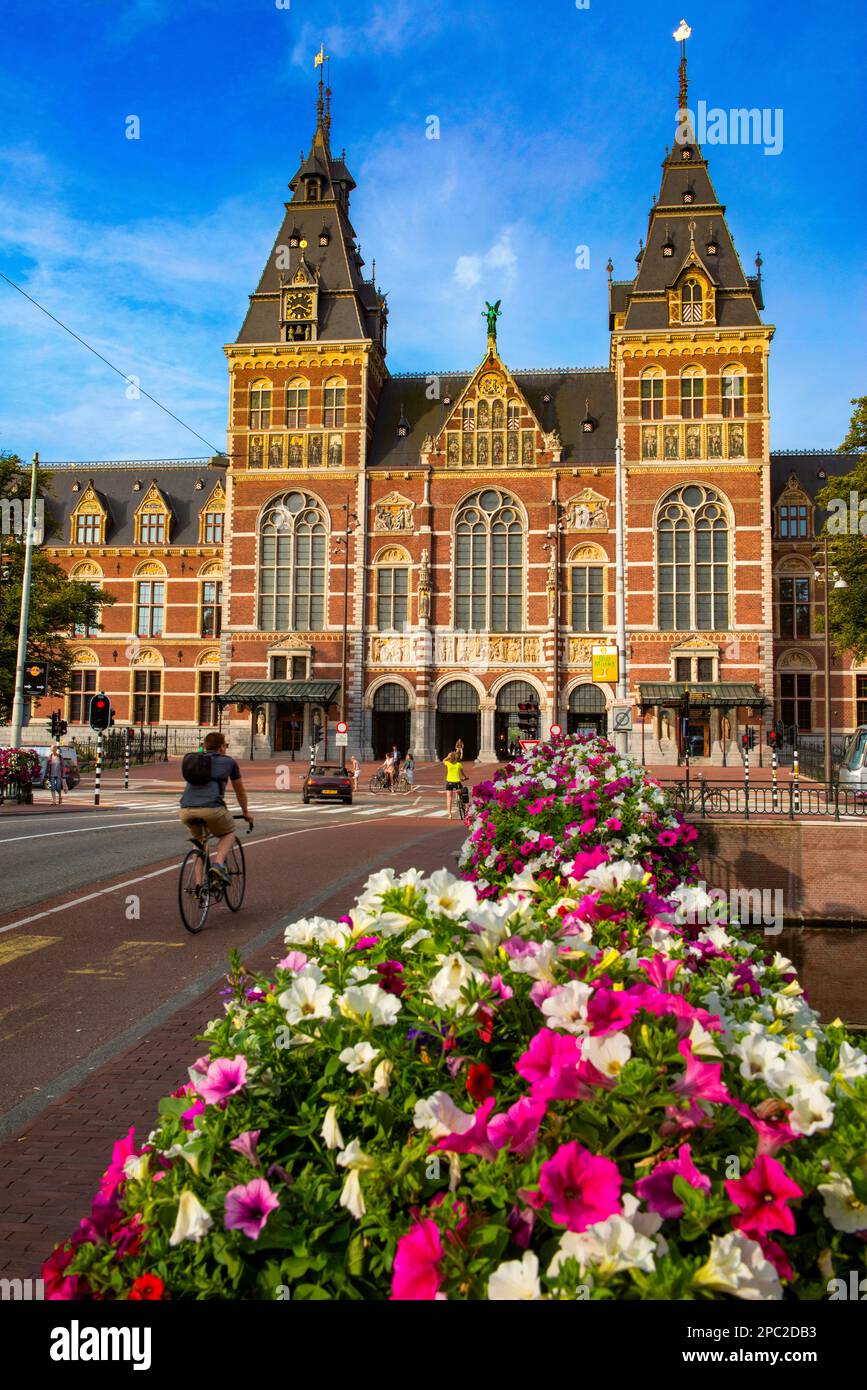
xmin=817 ymin=396 xmax=867 ymax=662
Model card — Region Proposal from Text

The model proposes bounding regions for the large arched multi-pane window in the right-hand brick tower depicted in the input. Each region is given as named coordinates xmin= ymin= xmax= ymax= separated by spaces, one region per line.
xmin=656 ymin=482 xmax=729 ymax=632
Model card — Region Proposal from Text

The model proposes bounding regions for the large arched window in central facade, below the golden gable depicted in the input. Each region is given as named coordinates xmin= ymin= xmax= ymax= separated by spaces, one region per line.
xmin=454 ymin=488 xmax=524 ymax=632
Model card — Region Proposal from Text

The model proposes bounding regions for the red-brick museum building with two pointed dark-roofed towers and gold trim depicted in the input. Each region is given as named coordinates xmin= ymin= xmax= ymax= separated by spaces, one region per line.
xmin=36 ymin=56 xmax=867 ymax=762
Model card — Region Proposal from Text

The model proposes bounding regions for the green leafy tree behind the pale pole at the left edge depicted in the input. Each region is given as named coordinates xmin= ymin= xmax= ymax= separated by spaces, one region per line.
xmin=0 ymin=453 xmax=114 ymax=720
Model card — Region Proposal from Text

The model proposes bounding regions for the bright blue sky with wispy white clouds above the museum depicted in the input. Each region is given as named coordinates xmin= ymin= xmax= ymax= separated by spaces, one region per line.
xmin=0 ymin=0 xmax=867 ymax=460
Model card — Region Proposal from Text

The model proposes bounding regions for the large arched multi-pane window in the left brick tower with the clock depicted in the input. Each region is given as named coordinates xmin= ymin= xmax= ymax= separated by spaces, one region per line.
xmin=258 ymin=492 xmax=328 ymax=632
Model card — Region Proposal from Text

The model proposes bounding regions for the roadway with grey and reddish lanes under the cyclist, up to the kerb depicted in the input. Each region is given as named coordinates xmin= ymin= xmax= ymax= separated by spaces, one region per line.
xmin=0 ymin=792 xmax=463 ymax=1129
